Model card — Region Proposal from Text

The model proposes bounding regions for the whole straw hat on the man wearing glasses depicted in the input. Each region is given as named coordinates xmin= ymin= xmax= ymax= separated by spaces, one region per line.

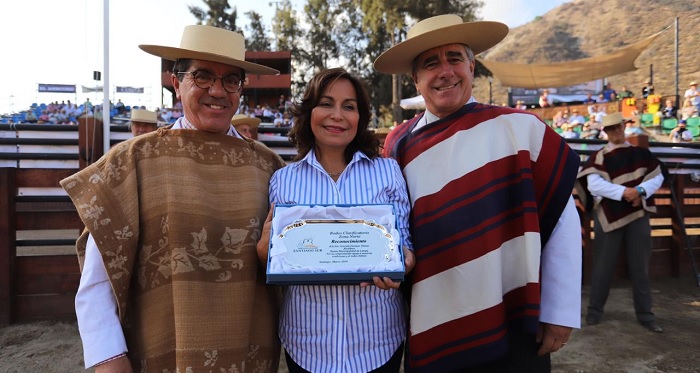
xmin=139 ymin=25 xmax=279 ymax=75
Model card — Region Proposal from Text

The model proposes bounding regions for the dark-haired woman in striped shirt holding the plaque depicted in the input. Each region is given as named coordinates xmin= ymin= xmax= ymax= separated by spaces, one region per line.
xmin=258 ymin=68 xmax=414 ymax=373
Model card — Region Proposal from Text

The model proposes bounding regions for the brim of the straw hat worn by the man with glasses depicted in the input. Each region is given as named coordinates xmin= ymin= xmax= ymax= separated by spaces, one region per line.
xmin=139 ymin=44 xmax=280 ymax=75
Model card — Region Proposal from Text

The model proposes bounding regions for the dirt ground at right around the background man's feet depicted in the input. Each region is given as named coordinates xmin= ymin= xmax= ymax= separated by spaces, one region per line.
xmin=552 ymin=276 xmax=700 ymax=373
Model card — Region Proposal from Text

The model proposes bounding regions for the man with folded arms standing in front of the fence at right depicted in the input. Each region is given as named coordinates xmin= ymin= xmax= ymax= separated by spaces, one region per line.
xmin=577 ymin=112 xmax=664 ymax=333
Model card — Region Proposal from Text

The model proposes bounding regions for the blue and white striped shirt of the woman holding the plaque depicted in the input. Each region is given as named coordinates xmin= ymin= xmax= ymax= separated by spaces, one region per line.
xmin=270 ymin=150 xmax=413 ymax=373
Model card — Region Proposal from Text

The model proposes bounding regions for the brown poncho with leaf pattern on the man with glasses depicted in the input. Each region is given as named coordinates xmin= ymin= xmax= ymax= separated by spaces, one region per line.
xmin=61 ymin=129 xmax=284 ymax=372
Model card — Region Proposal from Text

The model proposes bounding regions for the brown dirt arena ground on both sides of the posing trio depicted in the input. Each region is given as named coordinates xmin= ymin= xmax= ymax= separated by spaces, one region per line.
xmin=0 ymin=277 xmax=700 ymax=373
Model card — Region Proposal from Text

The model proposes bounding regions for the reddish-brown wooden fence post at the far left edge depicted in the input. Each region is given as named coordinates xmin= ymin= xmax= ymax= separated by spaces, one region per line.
xmin=0 ymin=168 xmax=17 ymax=325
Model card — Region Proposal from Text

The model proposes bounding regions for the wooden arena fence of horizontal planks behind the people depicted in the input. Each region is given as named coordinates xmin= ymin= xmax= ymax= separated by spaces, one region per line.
xmin=0 ymin=125 xmax=700 ymax=324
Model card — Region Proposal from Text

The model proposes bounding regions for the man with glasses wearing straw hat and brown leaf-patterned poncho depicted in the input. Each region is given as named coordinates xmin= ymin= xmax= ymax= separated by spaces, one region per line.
xmin=61 ymin=25 xmax=284 ymax=373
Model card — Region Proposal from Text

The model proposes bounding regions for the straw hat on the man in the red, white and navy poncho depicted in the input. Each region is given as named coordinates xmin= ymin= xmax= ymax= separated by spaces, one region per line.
xmin=374 ymin=14 xmax=508 ymax=74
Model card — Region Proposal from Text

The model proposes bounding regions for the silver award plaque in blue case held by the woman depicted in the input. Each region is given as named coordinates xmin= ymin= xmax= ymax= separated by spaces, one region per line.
xmin=267 ymin=205 xmax=404 ymax=285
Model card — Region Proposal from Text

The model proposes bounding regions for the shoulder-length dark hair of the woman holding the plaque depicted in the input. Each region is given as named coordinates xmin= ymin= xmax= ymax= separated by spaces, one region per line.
xmin=289 ymin=68 xmax=379 ymax=163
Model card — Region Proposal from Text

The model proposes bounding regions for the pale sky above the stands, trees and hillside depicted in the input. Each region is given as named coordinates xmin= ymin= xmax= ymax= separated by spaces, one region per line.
xmin=0 ymin=0 xmax=571 ymax=114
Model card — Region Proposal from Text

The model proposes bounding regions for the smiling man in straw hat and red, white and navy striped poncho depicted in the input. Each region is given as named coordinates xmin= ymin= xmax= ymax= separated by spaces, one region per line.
xmin=374 ymin=15 xmax=581 ymax=372
